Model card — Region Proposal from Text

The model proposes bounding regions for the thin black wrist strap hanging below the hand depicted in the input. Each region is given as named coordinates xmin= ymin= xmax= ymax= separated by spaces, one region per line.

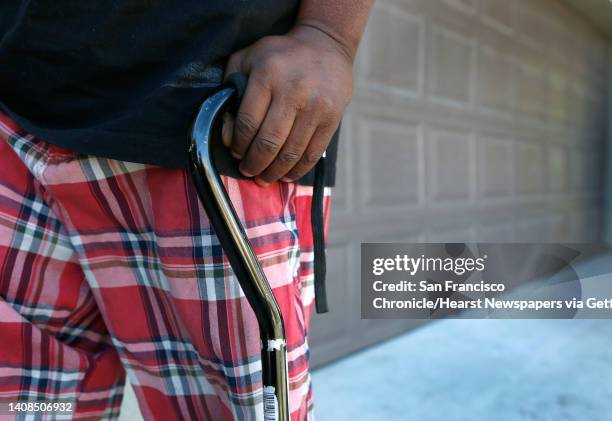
xmin=310 ymin=156 xmax=329 ymax=313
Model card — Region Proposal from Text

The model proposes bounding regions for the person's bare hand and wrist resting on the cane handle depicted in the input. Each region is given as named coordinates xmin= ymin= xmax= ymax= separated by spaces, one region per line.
xmin=223 ymin=0 xmax=373 ymax=187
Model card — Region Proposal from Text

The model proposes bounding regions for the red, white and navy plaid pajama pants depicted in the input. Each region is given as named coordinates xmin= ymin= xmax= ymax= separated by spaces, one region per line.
xmin=0 ymin=114 xmax=330 ymax=420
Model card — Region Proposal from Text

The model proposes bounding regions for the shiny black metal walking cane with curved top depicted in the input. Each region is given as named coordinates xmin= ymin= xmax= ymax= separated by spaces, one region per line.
xmin=189 ymin=75 xmax=289 ymax=421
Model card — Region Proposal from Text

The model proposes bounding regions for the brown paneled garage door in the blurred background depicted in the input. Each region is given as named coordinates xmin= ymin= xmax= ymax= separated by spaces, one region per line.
xmin=311 ymin=0 xmax=607 ymax=365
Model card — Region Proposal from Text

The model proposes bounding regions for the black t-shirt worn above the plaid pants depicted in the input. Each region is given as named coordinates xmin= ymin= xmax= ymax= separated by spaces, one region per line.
xmin=0 ymin=0 xmax=336 ymax=184
